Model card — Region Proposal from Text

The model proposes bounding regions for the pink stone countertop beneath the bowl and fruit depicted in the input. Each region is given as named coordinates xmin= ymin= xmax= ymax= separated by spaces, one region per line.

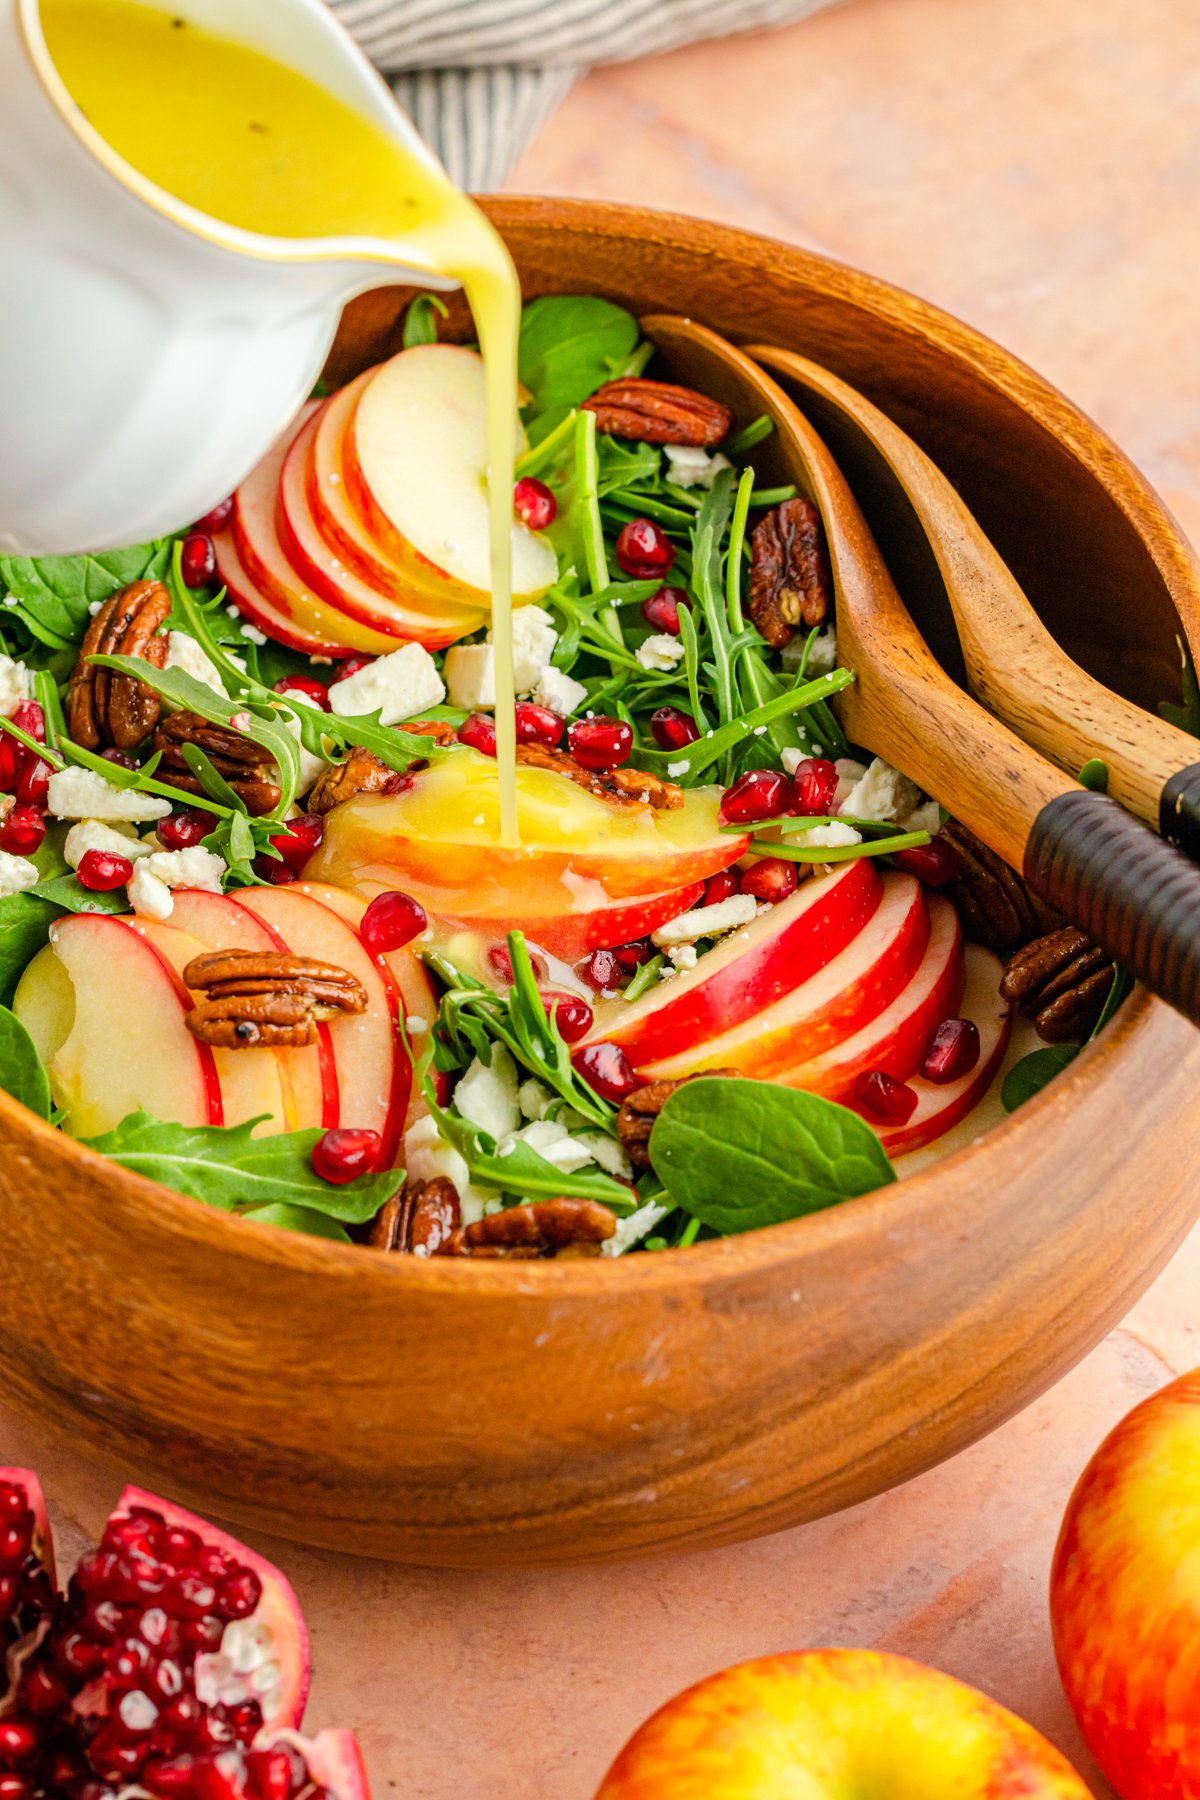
xmin=0 ymin=0 xmax=1200 ymax=1800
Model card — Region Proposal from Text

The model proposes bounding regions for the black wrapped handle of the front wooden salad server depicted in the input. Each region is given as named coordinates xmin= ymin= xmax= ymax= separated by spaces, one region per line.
xmin=1025 ymin=788 xmax=1200 ymax=1024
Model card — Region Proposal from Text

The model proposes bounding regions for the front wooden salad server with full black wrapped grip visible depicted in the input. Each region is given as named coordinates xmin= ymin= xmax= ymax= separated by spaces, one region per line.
xmin=642 ymin=315 xmax=1200 ymax=1024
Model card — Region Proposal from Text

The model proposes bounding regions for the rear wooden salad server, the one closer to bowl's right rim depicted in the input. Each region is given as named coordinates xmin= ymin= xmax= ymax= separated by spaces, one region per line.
xmin=747 ymin=344 xmax=1200 ymax=859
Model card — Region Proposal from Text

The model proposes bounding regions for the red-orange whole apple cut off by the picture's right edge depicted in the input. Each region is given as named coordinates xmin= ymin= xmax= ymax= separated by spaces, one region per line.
xmin=1051 ymin=1370 xmax=1200 ymax=1800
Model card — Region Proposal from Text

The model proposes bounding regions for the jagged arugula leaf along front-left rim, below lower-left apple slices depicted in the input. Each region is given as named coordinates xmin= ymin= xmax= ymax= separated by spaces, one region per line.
xmin=83 ymin=1112 xmax=403 ymax=1224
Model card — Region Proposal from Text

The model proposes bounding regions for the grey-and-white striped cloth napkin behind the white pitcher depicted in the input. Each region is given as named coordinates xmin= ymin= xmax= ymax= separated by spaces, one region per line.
xmin=329 ymin=0 xmax=831 ymax=193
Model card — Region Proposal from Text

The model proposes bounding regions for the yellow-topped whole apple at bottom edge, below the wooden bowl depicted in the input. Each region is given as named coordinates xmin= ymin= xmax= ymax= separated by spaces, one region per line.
xmin=596 ymin=1651 xmax=1088 ymax=1800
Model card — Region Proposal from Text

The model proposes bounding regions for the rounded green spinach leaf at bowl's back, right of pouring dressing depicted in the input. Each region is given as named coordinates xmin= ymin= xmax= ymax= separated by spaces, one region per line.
xmin=516 ymin=293 xmax=639 ymax=445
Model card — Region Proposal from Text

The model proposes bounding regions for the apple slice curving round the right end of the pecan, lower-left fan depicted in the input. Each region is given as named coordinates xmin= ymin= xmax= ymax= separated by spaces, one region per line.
xmin=239 ymin=884 xmax=412 ymax=1168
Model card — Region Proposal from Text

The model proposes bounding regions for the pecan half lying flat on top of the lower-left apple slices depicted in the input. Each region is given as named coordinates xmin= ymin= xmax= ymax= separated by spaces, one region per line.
xmin=184 ymin=950 xmax=367 ymax=1049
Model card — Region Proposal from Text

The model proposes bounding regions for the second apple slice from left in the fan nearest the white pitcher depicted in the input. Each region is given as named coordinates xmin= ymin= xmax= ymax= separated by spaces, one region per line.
xmin=275 ymin=401 xmax=486 ymax=650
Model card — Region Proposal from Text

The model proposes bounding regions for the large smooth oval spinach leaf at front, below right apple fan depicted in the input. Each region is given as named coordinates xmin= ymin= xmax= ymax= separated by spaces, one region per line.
xmin=651 ymin=1076 xmax=896 ymax=1237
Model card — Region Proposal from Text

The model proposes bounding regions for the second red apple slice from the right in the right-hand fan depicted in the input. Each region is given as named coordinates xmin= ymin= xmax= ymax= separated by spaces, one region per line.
xmin=777 ymin=892 xmax=963 ymax=1102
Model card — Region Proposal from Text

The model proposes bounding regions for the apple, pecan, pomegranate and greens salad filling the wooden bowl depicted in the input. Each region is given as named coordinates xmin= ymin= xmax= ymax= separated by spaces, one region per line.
xmin=0 ymin=295 xmax=1126 ymax=1260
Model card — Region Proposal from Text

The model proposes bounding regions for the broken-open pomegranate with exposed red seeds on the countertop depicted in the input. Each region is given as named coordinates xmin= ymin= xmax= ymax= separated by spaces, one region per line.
xmin=0 ymin=1469 xmax=367 ymax=1800
